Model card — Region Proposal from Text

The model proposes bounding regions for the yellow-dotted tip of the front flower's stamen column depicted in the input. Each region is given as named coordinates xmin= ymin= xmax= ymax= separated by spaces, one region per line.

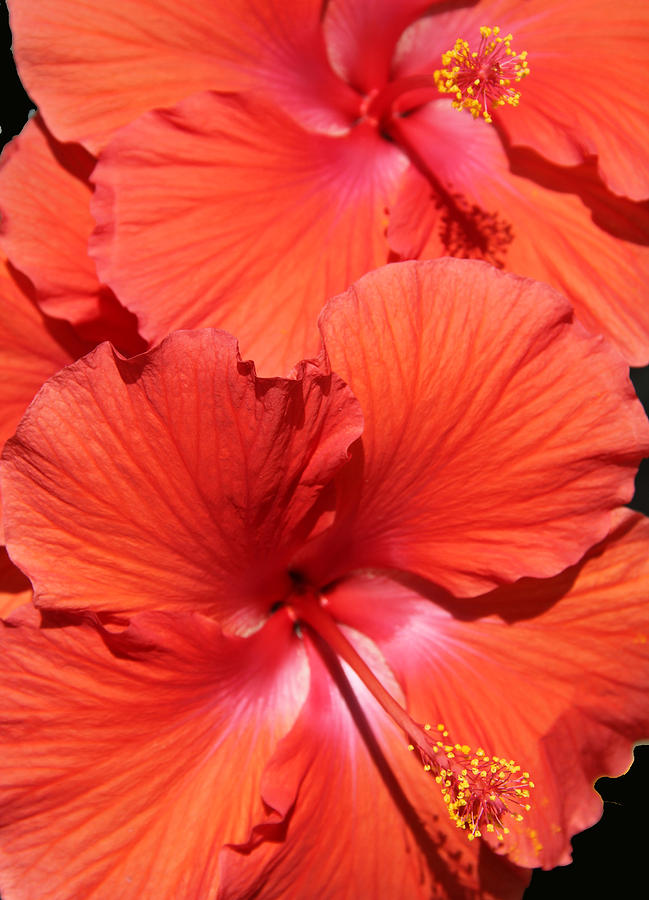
xmin=408 ymin=724 xmax=534 ymax=841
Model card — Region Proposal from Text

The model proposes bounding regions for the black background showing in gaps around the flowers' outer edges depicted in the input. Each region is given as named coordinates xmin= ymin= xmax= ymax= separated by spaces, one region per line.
xmin=0 ymin=0 xmax=649 ymax=900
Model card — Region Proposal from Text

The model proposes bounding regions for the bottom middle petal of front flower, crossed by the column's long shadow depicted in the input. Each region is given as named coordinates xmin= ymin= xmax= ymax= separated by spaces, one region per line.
xmin=219 ymin=633 xmax=529 ymax=900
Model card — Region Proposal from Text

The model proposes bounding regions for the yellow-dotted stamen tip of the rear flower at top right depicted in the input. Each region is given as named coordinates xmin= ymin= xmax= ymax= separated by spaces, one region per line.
xmin=434 ymin=25 xmax=530 ymax=122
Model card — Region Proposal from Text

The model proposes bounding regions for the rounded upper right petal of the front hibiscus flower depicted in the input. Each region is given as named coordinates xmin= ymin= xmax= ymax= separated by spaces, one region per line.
xmin=310 ymin=259 xmax=649 ymax=595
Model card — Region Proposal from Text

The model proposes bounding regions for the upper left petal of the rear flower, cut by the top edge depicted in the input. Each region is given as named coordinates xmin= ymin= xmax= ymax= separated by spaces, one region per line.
xmin=11 ymin=0 xmax=358 ymax=152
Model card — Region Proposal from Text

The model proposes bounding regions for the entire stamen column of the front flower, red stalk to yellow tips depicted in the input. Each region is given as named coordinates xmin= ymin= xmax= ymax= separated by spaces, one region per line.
xmin=288 ymin=589 xmax=534 ymax=841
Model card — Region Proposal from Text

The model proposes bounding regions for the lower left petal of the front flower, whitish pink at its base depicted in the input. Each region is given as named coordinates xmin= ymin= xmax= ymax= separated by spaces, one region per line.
xmin=0 ymin=613 xmax=308 ymax=900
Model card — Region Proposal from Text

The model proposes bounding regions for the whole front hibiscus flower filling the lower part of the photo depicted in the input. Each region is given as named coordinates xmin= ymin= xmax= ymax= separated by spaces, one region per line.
xmin=0 ymin=260 xmax=649 ymax=900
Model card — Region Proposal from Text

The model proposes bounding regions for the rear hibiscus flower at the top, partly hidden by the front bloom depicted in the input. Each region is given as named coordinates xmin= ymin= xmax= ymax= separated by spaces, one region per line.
xmin=6 ymin=0 xmax=649 ymax=372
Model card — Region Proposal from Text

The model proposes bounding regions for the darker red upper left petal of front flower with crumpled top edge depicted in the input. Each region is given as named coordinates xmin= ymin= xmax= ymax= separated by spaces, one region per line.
xmin=3 ymin=330 xmax=362 ymax=631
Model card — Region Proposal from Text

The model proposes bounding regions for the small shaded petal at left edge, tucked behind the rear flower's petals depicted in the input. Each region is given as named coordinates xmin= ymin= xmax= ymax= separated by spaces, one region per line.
xmin=0 ymin=116 xmax=146 ymax=353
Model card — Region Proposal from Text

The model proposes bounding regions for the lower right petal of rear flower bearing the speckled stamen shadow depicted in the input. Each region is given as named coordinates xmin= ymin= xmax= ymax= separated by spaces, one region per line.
xmin=388 ymin=103 xmax=649 ymax=365
